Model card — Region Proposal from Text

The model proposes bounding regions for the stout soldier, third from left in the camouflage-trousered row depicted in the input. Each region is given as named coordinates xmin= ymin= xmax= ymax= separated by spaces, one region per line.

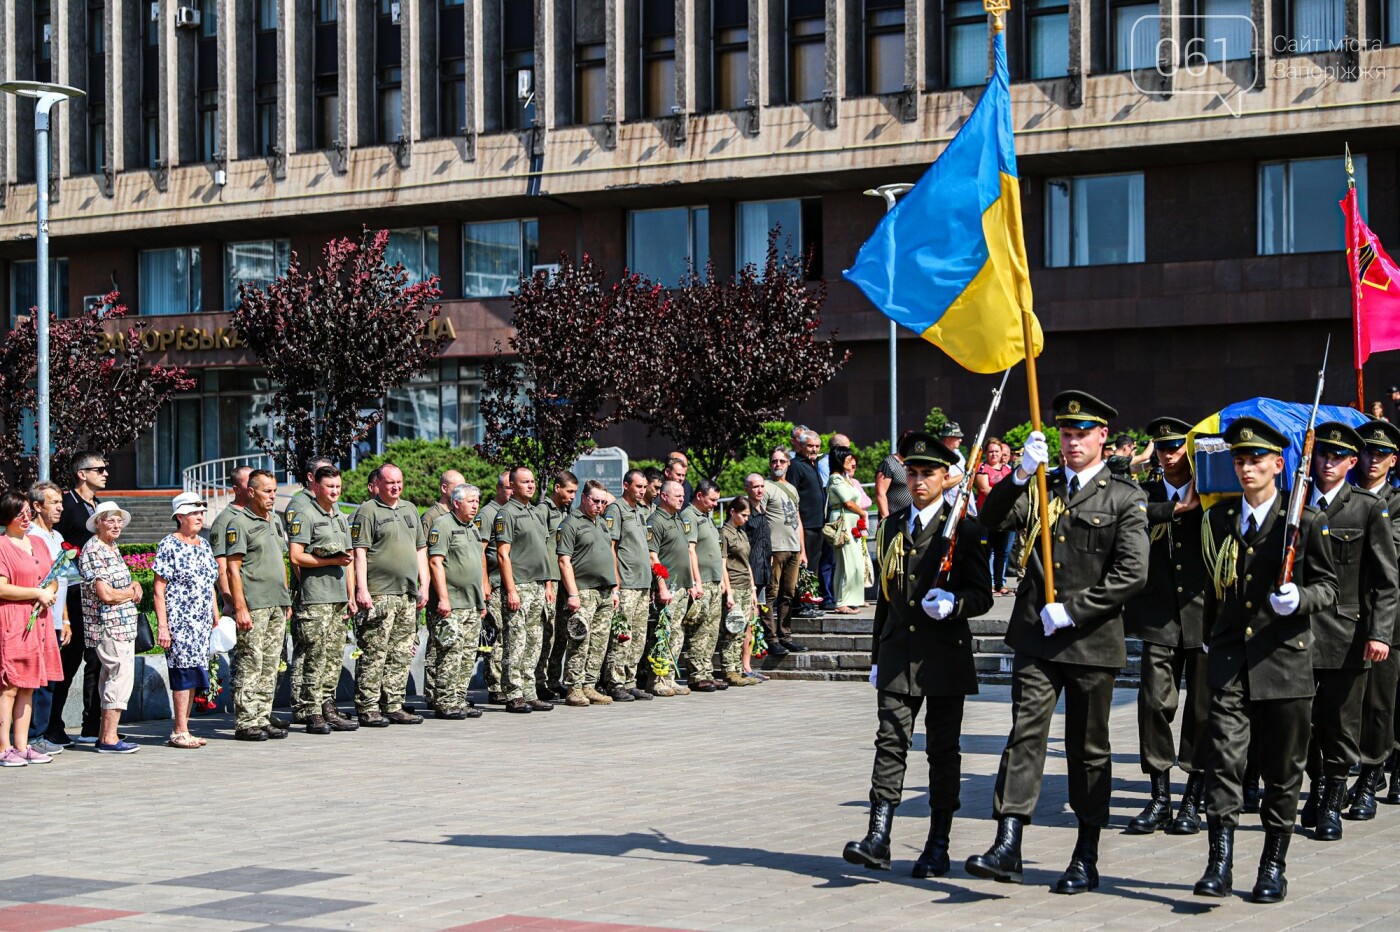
xmin=350 ymin=463 xmax=428 ymax=728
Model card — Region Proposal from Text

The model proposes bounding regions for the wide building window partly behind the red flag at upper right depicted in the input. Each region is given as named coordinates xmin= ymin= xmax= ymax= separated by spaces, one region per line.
xmin=1259 ymin=155 xmax=1366 ymax=256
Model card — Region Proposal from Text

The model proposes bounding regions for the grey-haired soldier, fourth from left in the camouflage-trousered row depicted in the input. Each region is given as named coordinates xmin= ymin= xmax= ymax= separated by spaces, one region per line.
xmin=428 ymin=483 xmax=491 ymax=719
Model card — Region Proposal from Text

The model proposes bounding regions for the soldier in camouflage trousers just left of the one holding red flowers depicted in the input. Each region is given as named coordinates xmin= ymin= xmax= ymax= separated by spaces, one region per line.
xmin=603 ymin=469 xmax=651 ymax=702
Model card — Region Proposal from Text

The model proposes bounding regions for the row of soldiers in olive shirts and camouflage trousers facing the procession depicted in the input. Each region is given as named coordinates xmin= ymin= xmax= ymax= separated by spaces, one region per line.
xmin=200 ymin=460 xmax=759 ymax=740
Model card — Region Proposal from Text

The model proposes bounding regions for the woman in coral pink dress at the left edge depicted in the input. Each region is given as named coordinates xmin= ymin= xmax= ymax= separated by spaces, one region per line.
xmin=0 ymin=493 xmax=63 ymax=767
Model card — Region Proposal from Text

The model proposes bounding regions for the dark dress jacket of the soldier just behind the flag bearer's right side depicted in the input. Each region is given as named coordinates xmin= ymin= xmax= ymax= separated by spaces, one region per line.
xmin=1120 ymin=480 xmax=1210 ymax=648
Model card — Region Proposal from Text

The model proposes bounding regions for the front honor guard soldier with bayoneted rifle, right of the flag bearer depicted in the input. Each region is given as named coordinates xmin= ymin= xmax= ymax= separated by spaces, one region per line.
xmin=1196 ymin=417 xmax=1337 ymax=903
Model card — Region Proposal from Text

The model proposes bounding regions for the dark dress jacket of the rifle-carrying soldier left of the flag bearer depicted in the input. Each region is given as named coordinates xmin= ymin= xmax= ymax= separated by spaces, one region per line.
xmin=871 ymin=504 xmax=993 ymax=696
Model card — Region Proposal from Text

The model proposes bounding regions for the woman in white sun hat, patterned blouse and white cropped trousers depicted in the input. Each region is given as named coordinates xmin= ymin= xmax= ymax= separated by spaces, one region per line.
xmin=78 ymin=501 xmax=141 ymax=754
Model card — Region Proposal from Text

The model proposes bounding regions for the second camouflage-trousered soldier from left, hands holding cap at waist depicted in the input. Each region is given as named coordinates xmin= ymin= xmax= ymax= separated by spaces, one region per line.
xmin=287 ymin=465 xmax=360 ymax=735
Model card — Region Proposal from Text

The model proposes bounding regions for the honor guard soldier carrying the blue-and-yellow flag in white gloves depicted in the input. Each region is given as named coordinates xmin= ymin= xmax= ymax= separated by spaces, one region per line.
xmin=967 ymin=392 xmax=1148 ymax=894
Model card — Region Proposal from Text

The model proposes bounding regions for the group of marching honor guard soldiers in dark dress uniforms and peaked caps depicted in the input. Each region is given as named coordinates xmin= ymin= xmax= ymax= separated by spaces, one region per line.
xmin=844 ymin=392 xmax=1400 ymax=903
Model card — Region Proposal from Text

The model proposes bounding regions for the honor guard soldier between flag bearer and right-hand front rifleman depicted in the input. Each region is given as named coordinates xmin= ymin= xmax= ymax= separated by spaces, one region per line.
xmin=1123 ymin=417 xmax=1210 ymax=835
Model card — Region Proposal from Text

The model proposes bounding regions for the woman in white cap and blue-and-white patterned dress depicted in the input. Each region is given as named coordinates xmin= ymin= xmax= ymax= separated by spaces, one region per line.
xmin=151 ymin=493 xmax=218 ymax=749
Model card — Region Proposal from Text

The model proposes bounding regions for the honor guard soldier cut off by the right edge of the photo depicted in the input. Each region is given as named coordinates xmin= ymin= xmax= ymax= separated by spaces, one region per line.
xmin=1347 ymin=421 xmax=1400 ymax=820
